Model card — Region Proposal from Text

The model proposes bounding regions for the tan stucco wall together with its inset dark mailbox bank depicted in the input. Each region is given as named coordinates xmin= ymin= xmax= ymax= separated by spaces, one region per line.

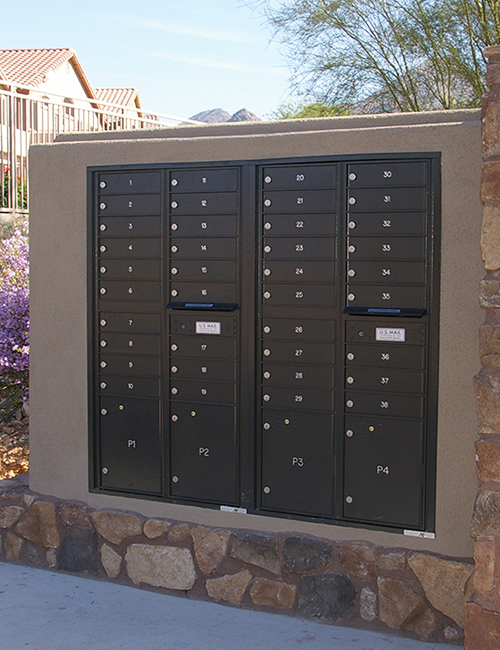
xmin=30 ymin=111 xmax=482 ymax=557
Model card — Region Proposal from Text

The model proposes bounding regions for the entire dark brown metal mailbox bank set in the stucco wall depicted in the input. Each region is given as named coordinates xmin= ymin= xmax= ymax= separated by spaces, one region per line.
xmin=89 ymin=154 xmax=440 ymax=532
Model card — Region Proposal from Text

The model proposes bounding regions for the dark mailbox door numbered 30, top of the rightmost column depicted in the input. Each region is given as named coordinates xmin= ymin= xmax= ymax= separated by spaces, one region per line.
xmin=347 ymin=160 xmax=427 ymax=187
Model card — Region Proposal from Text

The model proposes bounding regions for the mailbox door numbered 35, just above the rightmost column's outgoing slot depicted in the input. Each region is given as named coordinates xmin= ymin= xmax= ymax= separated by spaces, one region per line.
xmin=347 ymin=284 xmax=425 ymax=309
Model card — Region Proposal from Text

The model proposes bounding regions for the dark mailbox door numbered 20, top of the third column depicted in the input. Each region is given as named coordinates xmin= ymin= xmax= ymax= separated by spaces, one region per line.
xmin=262 ymin=164 xmax=337 ymax=190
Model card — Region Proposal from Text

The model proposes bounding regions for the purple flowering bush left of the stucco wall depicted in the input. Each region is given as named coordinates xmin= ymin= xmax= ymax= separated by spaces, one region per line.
xmin=0 ymin=221 xmax=30 ymax=421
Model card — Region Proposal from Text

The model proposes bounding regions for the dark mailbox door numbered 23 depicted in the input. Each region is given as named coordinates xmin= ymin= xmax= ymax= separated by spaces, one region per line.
xmin=263 ymin=237 xmax=335 ymax=261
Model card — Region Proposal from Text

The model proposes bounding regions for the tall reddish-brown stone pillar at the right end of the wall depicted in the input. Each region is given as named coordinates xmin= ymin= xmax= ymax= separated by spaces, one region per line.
xmin=466 ymin=46 xmax=500 ymax=650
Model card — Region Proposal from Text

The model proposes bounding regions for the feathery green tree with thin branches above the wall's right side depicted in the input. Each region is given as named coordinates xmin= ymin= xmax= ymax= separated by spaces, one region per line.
xmin=250 ymin=0 xmax=500 ymax=112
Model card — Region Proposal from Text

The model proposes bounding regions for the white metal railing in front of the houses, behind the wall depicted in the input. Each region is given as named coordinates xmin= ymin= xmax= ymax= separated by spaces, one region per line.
xmin=0 ymin=81 xmax=200 ymax=222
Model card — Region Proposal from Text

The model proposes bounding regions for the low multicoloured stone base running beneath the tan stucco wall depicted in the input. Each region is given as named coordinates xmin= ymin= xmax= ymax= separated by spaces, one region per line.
xmin=0 ymin=478 xmax=473 ymax=643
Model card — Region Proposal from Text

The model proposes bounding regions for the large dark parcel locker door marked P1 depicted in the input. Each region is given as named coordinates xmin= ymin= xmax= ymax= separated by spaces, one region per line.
xmin=98 ymin=396 xmax=162 ymax=494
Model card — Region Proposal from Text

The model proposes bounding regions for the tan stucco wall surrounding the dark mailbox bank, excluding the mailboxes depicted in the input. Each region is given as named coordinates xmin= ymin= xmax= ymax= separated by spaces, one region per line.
xmin=30 ymin=111 xmax=482 ymax=557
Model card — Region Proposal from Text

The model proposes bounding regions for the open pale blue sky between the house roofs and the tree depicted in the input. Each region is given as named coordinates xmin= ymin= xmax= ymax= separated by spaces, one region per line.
xmin=0 ymin=0 xmax=289 ymax=117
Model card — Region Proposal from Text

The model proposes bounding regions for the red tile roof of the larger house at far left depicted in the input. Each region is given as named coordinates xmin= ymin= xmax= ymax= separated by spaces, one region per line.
xmin=0 ymin=47 xmax=94 ymax=98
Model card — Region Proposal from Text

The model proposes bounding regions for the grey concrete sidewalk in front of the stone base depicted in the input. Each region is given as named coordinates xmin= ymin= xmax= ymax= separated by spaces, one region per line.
xmin=0 ymin=563 xmax=463 ymax=650
